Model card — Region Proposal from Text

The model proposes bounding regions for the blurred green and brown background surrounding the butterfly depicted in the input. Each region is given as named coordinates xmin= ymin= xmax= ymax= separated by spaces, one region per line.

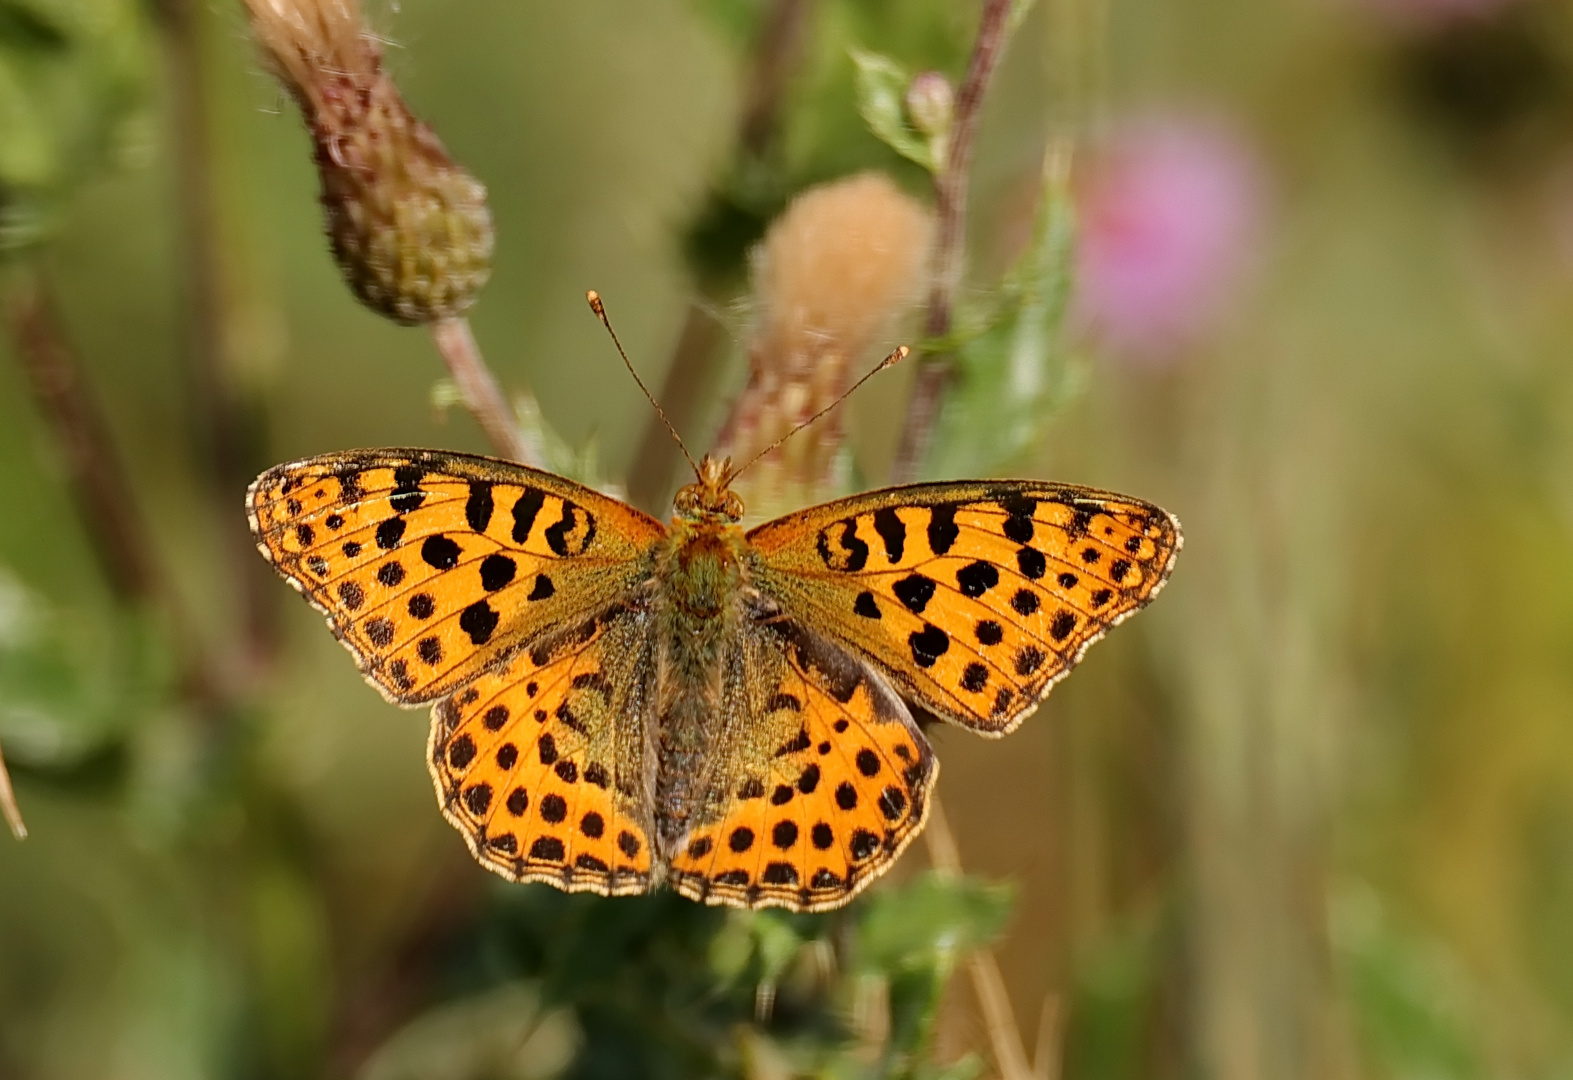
xmin=0 ymin=0 xmax=1573 ymax=1080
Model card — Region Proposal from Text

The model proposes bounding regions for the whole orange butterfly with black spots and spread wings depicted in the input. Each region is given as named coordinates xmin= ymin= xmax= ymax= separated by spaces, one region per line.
xmin=247 ymin=450 xmax=1181 ymax=912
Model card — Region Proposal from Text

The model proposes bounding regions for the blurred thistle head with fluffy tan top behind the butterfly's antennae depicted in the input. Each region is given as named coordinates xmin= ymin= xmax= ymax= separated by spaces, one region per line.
xmin=717 ymin=173 xmax=933 ymax=512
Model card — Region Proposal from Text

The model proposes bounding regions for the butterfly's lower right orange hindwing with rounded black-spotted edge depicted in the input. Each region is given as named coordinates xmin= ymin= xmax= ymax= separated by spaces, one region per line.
xmin=669 ymin=610 xmax=939 ymax=912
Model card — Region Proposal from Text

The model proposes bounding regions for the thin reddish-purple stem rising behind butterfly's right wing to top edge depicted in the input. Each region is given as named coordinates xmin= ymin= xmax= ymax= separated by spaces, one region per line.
xmin=890 ymin=0 xmax=1011 ymax=484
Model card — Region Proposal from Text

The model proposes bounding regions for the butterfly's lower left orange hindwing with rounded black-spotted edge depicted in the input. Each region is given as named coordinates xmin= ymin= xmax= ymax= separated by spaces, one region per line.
xmin=428 ymin=607 xmax=656 ymax=896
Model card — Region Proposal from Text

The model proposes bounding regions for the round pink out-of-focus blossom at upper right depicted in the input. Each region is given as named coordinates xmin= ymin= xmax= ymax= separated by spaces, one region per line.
xmin=1074 ymin=116 xmax=1265 ymax=363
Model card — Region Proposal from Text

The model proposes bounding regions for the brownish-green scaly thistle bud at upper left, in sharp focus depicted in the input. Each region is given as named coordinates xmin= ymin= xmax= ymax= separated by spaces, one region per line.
xmin=235 ymin=0 xmax=492 ymax=324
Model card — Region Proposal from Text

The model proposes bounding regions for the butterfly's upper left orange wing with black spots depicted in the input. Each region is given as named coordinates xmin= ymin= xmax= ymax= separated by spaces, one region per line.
xmin=245 ymin=450 xmax=665 ymax=704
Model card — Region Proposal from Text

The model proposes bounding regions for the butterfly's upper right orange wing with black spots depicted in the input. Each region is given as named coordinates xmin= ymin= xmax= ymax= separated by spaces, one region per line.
xmin=747 ymin=481 xmax=1181 ymax=734
